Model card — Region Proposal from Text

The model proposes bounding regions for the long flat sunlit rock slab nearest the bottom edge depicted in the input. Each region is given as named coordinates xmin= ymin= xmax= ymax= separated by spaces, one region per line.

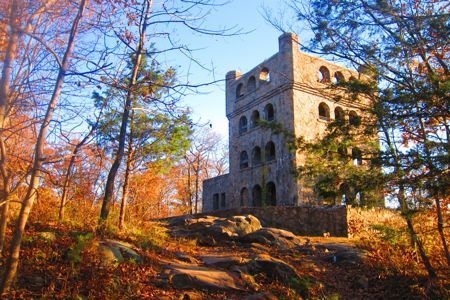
xmin=163 ymin=264 xmax=246 ymax=291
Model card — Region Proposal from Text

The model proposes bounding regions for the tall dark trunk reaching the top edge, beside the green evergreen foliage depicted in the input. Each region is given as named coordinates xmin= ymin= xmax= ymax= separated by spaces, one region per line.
xmin=99 ymin=1 xmax=152 ymax=225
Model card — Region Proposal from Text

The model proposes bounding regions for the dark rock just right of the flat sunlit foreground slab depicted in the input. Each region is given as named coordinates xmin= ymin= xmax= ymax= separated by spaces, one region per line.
xmin=246 ymin=254 xmax=298 ymax=280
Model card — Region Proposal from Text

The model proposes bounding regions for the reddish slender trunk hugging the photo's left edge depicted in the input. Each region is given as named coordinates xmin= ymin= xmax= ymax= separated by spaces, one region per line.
xmin=0 ymin=0 xmax=19 ymax=255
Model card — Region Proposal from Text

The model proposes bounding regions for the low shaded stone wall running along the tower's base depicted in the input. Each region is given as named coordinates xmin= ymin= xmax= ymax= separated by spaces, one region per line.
xmin=197 ymin=205 xmax=348 ymax=236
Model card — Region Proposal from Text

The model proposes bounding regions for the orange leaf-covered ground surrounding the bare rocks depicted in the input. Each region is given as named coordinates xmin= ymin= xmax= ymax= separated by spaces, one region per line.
xmin=0 ymin=216 xmax=446 ymax=300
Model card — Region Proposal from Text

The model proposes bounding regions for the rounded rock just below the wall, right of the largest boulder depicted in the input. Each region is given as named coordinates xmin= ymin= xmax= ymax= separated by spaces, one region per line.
xmin=240 ymin=228 xmax=302 ymax=250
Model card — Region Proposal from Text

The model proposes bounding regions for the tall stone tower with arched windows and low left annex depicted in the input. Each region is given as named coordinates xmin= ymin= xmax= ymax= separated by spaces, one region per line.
xmin=203 ymin=33 xmax=365 ymax=212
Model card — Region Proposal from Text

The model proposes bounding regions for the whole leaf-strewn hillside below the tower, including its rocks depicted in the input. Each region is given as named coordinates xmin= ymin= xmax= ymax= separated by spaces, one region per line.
xmin=2 ymin=215 xmax=445 ymax=299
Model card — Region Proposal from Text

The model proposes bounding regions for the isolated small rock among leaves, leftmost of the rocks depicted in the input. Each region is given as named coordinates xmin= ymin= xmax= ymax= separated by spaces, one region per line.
xmin=98 ymin=240 xmax=142 ymax=265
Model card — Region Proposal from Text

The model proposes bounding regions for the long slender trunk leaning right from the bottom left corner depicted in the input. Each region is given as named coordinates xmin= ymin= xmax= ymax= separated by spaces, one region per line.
xmin=0 ymin=0 xmax=86 ymax=295
